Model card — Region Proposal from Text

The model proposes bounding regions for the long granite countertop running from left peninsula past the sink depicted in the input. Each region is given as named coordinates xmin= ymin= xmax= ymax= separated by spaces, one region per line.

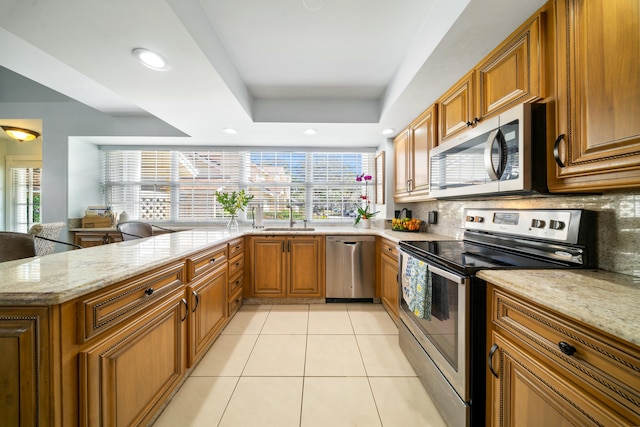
xmin=0 ymin=227 xmax=451 ymax=306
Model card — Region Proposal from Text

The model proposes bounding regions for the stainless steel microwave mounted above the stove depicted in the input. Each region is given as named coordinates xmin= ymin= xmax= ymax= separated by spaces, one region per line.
xmin=429 ymin=103 xmax=547 ymax=199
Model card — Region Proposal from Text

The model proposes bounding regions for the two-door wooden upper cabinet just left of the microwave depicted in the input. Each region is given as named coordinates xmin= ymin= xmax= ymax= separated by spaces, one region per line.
xmin=393 ymin=104 xmax=438 ymax=202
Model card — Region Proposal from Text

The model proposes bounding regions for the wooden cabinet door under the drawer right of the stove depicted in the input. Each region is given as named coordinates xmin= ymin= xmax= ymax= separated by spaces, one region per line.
xmin=487 ymin=333 xmax=630 ymax=427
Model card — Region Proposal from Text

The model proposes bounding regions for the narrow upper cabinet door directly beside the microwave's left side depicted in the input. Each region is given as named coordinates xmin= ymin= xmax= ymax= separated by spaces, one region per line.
xmin=410 ymin=104 xmax=438 ymax=196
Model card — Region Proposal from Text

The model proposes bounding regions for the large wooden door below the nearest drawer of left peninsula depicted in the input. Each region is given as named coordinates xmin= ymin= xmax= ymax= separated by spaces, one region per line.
xmin=79 ymin=290 xmax=188 ymax=426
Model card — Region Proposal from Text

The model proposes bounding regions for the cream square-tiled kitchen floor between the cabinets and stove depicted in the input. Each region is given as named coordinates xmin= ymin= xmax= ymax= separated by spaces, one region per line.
xmin=154 ymin=304 xmax=446 ymax=427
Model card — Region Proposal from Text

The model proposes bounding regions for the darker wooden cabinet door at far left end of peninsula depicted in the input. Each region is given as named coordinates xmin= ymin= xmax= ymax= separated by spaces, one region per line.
xmin=0 ymin=307 xmax=51 ymax=427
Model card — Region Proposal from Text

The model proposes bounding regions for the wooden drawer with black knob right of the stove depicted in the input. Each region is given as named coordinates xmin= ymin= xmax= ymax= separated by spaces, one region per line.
xmin=492 ymin=289 xmax=640 ymax=416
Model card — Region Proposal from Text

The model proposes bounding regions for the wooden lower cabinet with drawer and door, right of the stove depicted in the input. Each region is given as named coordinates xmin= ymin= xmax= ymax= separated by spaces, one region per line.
xmin=487 ymin=286 xmax=640 ymax=427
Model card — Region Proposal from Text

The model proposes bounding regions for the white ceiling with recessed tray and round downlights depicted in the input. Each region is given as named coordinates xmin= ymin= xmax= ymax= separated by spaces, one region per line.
xmin=0 ymin=0 xmax=545 ymax=147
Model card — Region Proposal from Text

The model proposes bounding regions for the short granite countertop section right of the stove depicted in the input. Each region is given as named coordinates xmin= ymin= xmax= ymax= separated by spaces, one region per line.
xmin=477 ymin=270 xmax=640 ymax=345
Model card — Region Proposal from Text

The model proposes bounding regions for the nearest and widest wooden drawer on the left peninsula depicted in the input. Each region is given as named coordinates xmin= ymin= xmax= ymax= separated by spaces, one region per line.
xmin=78 ymin=262 xmax=184 ymax=342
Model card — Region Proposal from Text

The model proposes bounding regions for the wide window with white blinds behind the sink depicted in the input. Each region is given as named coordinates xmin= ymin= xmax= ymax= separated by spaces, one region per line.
xmin=103 ymin=147 xmax=374 ymax=222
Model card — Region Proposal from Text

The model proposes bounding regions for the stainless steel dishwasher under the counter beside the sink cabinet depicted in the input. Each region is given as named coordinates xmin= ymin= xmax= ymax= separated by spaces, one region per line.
xmin=325 ymin=236 xmax=376 ymax=302
